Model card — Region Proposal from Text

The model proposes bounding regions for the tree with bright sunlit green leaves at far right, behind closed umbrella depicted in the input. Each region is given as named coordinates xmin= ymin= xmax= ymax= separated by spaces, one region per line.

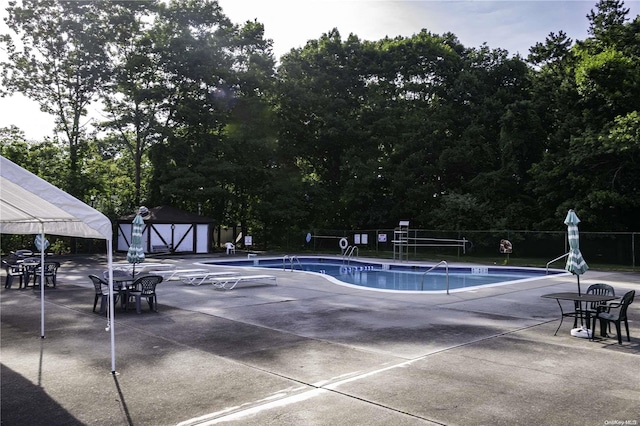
xmin=531 ymin=0 xmax=640 ymax=230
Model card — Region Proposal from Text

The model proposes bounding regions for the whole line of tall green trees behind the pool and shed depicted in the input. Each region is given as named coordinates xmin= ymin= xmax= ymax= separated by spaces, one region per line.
xmin=0 ymin=0 xmax=640 ymax=250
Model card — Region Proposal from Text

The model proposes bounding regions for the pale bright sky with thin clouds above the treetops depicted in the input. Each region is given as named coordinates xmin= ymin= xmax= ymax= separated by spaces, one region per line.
xmin=0 ymin=0 xmax=640 ymax=140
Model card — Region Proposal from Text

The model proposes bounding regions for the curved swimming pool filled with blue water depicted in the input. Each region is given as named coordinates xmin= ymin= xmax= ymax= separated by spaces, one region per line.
xmin=205 ymin=256 xmax=567 ymax=292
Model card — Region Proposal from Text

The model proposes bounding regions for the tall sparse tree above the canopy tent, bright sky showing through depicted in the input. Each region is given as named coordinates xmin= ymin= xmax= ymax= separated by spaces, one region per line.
xmin=2 ymin=0 xmax=137 ymax=198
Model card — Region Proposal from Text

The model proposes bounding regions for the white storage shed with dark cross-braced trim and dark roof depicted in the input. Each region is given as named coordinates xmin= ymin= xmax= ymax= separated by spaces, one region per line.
xmin=116 ymin=206 xmax=214 ymax=253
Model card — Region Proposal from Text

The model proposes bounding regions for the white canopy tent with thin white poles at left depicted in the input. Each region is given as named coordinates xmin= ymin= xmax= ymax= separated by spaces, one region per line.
xmin=0 ymin=156 xmax=116 ymax=373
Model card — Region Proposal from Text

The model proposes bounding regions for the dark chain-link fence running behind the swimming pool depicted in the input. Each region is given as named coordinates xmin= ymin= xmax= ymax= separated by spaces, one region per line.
xmin=271 ymin=229 xmax=640 ymax=269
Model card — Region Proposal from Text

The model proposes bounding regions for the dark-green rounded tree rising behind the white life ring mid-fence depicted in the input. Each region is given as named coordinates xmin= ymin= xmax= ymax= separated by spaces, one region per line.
xmin=278 ymin=29 xmax=366 ymax=227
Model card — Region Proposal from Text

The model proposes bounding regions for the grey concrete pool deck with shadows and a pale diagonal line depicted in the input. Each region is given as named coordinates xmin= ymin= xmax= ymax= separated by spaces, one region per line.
xmin=0 ymin=255 xmax=640 ymax=426
